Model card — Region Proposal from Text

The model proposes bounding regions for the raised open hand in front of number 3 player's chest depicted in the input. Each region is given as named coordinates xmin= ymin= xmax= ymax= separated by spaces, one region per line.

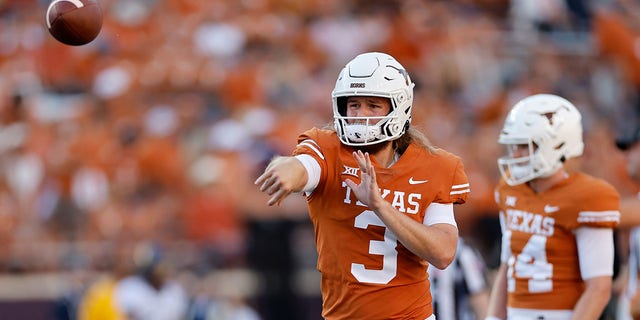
xmin=345 ymin=150 xmax=384 ymax=210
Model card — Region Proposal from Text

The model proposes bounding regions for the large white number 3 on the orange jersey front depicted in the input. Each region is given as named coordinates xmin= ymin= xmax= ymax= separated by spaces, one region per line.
xmin=351 ymin=210 xmax=398 ymax=284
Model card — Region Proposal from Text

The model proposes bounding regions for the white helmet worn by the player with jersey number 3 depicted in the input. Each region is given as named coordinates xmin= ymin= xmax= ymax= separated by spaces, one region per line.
xmin=331 ymin=52 xmax=415 ymax=146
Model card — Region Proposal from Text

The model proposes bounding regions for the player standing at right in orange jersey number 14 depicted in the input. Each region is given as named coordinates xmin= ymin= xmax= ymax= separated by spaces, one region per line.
xmin=486 ymin=94 xmax=620 ymax=320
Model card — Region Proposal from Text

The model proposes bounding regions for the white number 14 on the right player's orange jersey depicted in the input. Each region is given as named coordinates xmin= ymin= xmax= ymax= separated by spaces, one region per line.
xmin=506 ymin=230 xmax=553 ymax=293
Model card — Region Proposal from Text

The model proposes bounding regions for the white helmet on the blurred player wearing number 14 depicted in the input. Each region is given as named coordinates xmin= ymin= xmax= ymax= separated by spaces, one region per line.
xmin=498 ymin=94 xmax=584 ymax=186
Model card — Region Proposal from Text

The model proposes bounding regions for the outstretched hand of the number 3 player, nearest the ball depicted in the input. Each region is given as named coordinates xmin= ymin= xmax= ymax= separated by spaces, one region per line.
xmin=254 ymin=157 xmax=297 ymax=206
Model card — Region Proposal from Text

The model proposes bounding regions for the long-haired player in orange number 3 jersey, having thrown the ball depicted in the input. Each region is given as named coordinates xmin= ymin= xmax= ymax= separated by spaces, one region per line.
xmin=255 ymin=52 xmax=469 ymax=320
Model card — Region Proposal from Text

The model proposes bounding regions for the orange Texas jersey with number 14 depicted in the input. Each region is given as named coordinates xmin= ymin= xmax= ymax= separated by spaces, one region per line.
xmin=496 ymin=173 xmax=620 ymax=310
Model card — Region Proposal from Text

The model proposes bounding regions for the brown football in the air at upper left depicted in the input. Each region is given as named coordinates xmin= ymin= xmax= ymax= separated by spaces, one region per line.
xmin=46 ymin=0 xmax=102 ymax=46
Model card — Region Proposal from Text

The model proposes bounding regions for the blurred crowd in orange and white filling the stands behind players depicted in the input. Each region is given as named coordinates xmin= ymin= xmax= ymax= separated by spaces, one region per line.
xmin=0 ymin=0 xmax=640 ymax=319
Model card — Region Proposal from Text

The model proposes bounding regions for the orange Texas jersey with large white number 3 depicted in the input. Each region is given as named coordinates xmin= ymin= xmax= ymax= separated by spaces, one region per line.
xmin=294 ymin=128 xmax=469 ymax=320
